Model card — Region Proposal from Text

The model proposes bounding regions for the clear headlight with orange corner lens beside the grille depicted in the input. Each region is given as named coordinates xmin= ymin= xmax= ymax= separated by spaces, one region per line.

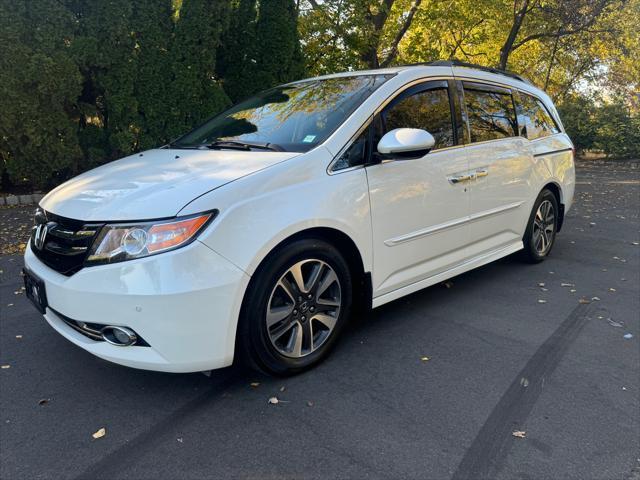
xmin=85 ymin=211 xmax=218 ymax=265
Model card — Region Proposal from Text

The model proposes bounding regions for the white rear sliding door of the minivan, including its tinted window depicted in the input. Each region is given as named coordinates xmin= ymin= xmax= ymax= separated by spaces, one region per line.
xmin=462 ymin=81 xmax=532 ymax=257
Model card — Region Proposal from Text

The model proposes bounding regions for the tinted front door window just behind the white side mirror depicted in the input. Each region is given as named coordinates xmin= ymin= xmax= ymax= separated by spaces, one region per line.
xmin=384 ymin=88 xmax=454 ymax=148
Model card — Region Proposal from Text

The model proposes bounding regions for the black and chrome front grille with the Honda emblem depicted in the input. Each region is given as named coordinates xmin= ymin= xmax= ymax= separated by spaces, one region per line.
xmin=29 ymin=212 xmax=103 ymax=276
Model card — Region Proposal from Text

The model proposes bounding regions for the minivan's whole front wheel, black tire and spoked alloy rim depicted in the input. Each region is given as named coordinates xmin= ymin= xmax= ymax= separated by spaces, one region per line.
xmin=238 ymin=239 xmax=352 ymax=375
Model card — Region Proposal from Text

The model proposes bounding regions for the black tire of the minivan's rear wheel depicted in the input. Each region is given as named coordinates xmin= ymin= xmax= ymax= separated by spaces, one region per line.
xmin=522 ymin=188 xmax=560 ymax=263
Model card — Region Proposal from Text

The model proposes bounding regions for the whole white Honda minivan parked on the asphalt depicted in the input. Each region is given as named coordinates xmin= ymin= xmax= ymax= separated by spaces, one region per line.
xmin=24 ymin=61 xmax=575 ymax=374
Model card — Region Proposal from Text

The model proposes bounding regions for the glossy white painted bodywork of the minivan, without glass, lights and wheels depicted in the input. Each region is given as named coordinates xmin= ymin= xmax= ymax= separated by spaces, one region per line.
xmin=25 ymin=62 xmax=575 ymax=372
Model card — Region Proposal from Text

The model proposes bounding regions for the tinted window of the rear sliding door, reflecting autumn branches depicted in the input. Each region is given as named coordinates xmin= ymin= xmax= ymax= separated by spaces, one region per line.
xmin=464 ymin=85 xmax=517 ymax=142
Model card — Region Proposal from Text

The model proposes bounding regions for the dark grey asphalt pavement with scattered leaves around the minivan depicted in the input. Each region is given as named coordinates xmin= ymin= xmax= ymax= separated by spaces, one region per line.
xmin=0 ymin=162 xmax=640 ymax=480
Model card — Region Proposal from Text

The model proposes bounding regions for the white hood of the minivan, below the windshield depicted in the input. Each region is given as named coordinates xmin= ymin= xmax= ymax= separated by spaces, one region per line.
xmin=40 ymin=149 xmax=300 ymax=221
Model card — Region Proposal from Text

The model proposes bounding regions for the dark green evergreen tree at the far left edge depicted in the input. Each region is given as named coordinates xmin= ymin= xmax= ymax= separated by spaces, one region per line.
xmin=0 ymin=0 xmax=82 ymax=188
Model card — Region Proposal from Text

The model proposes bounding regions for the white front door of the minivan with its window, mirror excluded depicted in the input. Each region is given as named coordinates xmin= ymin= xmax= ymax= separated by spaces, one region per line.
xmin=366 ymin=81 xmax=469 ymax=298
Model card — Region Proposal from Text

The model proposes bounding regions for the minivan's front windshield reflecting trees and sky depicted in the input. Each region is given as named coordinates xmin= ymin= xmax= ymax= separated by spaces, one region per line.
xmin=170 ymin=75 xmax=390 ymax=152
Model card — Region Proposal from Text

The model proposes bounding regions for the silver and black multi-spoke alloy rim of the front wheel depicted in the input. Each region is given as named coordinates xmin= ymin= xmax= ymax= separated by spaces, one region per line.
xmin=265 ymin=259 xmax=342 ymax=358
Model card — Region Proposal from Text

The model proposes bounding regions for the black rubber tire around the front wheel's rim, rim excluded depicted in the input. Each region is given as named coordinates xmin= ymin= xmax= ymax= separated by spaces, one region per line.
xmin=238 ymin=239 xmax=353 ymax=375
